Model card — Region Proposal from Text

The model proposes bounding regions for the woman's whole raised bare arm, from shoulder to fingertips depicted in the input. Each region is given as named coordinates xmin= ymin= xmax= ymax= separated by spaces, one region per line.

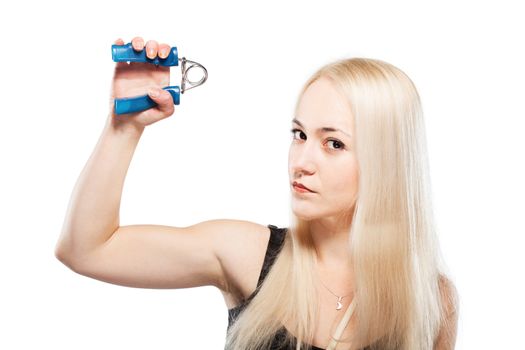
xmin=55 ymin=38 xmax=268 ymax=292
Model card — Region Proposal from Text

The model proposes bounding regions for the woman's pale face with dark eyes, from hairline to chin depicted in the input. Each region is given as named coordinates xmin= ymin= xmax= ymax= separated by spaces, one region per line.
xmin=288 ymin=78 xmax=358 ymax=220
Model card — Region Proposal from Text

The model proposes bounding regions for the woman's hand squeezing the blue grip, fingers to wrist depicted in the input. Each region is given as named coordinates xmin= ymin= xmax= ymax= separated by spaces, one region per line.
xmin=110 ymin=37 xmax=175 ymax=130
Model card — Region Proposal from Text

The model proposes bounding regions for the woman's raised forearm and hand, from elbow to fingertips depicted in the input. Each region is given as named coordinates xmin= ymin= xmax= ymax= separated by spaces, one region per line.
xmin=55 ymin=38 xmax=174 ymax=265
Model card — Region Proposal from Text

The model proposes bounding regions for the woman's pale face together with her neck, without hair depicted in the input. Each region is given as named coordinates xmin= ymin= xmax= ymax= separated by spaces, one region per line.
xmin=288 ymin=78 xmax=358 ymax=278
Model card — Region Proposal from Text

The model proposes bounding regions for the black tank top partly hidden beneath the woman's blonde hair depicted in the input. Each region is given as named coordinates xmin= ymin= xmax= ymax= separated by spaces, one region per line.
xmin=224 ymin=225 xmax=369 ymax=350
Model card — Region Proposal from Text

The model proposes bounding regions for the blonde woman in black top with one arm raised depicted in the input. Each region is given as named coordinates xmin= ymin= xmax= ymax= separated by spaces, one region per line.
xmin=52 ymin=37 xmax=458 ymax=350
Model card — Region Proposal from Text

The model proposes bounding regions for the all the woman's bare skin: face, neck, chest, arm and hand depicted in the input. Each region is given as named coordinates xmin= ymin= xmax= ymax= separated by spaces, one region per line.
xmin=55 ymin=37 xmax=454 ymax=350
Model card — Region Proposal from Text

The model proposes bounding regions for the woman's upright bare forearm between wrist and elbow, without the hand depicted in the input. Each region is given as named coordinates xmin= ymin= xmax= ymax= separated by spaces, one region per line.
xmin=55 ymin=117 xmax=144 ymax=263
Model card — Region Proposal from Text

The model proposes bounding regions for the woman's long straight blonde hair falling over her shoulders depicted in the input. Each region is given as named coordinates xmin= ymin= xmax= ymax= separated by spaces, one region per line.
xmin=226 ymin=58 xmax=458 ymax=350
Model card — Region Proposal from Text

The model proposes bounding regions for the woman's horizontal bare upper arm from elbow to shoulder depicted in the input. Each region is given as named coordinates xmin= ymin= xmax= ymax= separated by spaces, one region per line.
xmin=65 ymin=219 xmax=263 ymax=291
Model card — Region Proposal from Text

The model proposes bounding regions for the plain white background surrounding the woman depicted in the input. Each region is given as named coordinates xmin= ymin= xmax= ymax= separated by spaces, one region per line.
xmin=0 ymin=1 xmax=525 ymax=350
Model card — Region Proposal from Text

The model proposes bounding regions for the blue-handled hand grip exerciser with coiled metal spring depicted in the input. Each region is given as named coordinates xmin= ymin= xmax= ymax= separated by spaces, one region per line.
xmin=111 ymin=43 xmax=208 ymax=114
